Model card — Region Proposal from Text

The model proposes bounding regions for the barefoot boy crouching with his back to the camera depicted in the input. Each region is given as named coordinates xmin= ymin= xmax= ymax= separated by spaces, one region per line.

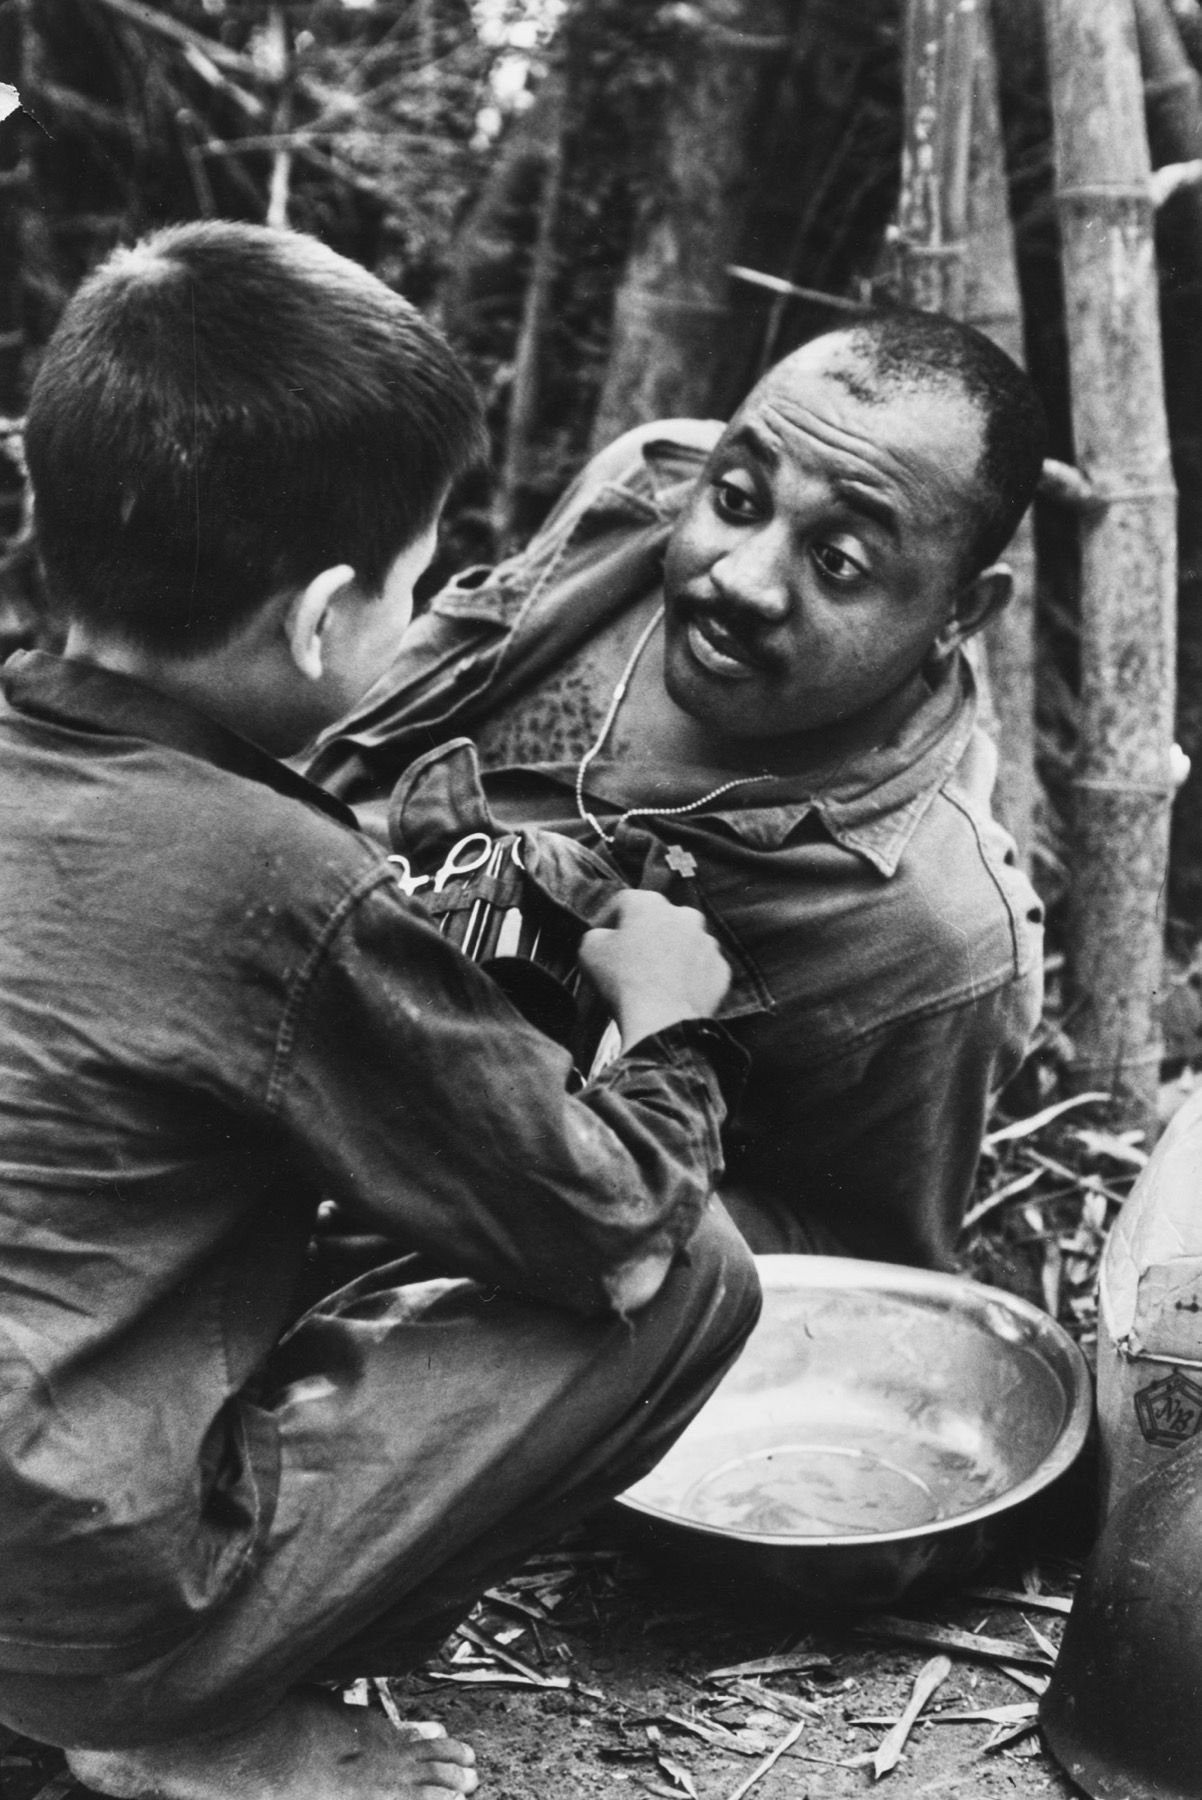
xmin=0 ymin=223 xmax=756 ymax=1800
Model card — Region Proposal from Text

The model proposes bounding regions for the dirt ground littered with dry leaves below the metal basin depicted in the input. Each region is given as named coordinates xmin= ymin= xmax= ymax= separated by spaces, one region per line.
xmin=0 ymin=1471 xmax=1090 ymax=1800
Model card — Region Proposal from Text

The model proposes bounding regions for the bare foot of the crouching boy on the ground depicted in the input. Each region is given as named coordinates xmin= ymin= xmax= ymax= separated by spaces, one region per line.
xmin=67 ymin=1692 xmax=479 ymax=1800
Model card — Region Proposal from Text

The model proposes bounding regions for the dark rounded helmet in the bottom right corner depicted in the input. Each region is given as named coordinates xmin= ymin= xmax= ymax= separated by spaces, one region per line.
xmin=1040 ymin=1438 xmax=1202 ymax=1800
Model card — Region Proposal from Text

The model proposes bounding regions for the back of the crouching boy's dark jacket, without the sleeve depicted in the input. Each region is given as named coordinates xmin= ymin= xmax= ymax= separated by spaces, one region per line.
xmin=0 ymin=653 xmax=372 ymax=1667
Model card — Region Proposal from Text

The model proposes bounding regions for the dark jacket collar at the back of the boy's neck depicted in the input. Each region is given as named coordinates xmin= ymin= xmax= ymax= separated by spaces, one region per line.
xmin=0 ymin=650 xmax=358 ymax=830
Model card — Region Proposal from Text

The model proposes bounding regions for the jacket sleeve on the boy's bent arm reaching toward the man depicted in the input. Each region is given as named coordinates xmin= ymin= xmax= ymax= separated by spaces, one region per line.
xmin=268 ymin=875 xmax=741 ymax=1314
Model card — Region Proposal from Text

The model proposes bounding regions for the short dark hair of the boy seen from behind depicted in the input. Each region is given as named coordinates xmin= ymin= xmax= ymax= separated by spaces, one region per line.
xmin=25 ymin=221 xmax=484 ymax=655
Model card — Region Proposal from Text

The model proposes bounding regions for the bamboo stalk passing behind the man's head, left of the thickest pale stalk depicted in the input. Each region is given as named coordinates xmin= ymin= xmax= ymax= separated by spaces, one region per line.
xmin=964 ymin=0 xmax=1038 ymax=868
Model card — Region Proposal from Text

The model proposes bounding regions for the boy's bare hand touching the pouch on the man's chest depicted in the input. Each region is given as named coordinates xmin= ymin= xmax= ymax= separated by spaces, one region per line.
xmin=579 ymin=891 xmax=731 ymax=1049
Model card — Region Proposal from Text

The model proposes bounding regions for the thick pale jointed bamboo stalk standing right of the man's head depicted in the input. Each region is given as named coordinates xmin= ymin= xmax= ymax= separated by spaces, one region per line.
xmin=1044 ymin=0 xmax=1177 ymax=1127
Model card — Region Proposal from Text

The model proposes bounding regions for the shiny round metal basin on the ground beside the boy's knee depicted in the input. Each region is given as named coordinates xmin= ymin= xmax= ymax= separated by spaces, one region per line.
xmin=619 ymin=1256 xmax=1092 ymax=1606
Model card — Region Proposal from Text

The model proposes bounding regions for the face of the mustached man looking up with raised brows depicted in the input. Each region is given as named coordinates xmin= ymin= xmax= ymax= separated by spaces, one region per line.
xmin=664 ymin=337 xmax=982 ymax=740
